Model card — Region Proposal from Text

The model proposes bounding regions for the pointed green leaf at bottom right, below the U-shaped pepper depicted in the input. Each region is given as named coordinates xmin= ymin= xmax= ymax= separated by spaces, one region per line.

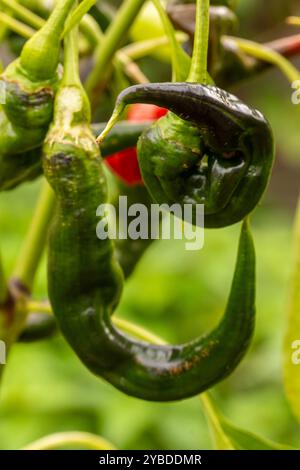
xmin=201 ymin=393 xmax=296 ymax=450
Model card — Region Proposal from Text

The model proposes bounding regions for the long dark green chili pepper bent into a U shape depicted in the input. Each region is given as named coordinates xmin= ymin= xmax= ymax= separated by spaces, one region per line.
xmin=44 ymin=28 xmax=255 ymax=401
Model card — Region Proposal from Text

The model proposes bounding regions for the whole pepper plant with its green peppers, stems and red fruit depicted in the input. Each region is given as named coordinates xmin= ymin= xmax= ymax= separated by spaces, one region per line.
xmin=0 ymin=0 xmax=300 ymax=449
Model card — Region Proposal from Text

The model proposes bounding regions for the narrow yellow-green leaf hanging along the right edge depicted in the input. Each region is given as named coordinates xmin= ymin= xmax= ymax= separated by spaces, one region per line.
xmin=284 ymin=199 xmax=300 ymax=421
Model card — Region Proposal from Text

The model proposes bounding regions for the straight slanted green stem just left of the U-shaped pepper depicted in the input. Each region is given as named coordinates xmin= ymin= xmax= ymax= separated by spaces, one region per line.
xmin=13 ymin=182 xmax=55 ymax=291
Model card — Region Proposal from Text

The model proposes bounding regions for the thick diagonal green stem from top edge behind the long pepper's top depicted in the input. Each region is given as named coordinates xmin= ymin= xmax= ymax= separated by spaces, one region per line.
xmin=85 ymin=0 xmax=145 ymax=100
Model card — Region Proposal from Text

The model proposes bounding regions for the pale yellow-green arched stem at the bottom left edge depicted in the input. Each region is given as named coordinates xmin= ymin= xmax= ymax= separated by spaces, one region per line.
xmin=22 ymin=432 xmax=116 ymax=450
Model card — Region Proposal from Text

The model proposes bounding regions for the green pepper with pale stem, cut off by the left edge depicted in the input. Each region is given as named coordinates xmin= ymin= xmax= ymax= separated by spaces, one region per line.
xmin=0 ymin=0 xmax=74 ymax=190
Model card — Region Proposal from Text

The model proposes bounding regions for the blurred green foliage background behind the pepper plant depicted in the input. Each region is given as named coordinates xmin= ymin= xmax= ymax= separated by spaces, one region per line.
xmin=0 ymin=0 xmax=300 ymax=449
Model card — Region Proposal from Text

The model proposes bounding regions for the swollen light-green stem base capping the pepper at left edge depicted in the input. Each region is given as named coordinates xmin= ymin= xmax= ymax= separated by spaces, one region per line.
xmin=20 ymin=0 xmax=75 ymax=81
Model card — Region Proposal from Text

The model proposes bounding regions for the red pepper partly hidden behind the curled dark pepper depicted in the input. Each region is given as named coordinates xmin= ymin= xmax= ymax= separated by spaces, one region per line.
xmin=105 ymin=104 xmax=168 ymax=185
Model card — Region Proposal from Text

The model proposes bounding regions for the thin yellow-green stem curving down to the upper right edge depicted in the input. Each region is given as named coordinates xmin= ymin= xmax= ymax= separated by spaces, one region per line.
xmin=226 ymin=36 xmax=300 ymax=82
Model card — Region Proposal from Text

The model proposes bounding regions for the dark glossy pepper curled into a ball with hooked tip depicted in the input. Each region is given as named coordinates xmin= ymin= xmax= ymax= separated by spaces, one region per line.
xmin=104 ymin=83 xmax=274 ymax=228
